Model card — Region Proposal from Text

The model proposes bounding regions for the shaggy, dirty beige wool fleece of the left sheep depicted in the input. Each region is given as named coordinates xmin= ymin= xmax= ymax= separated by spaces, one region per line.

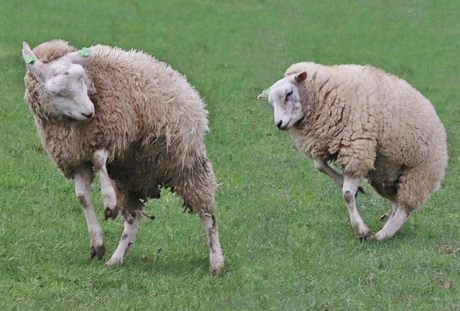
xmin=25 ymin=40 xmax=217 ymax=216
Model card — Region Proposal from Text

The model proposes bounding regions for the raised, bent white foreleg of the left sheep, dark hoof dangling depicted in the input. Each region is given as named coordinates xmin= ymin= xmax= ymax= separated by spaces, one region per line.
xmin=92 ymin=149 xmax=118 ymax=220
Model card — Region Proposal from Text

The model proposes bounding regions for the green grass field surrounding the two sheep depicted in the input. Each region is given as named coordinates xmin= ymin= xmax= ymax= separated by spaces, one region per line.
xmin=0 ymin=0 xmax=460 ymax=310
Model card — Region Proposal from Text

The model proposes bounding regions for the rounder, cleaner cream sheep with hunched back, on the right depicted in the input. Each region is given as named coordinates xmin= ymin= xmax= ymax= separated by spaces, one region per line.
xmin=258 ymin=62 xmax=448 ymax=241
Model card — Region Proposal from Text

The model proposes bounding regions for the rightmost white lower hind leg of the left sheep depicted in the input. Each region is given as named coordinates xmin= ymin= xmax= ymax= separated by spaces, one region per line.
xmin=200 ymin=213 xmax=224 ymax=272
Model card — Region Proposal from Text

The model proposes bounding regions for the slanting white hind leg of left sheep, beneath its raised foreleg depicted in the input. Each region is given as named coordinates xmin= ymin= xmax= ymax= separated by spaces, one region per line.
xmin=105 ymin=210 xmax=142 ymax=266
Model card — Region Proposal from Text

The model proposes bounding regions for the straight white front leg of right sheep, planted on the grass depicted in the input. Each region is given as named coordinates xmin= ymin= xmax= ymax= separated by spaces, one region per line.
xmin=342 ymin=175 xmax=369 ymax=238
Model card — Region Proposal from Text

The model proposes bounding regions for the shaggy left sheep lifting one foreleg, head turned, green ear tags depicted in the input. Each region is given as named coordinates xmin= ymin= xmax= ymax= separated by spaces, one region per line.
xmin=22 ymin=39 xmax=224 ymax=272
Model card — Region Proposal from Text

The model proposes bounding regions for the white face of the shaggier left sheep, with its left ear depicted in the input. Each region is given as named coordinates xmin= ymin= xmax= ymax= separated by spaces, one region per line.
xmin=22 ymin=43 xmax=94 ymax=121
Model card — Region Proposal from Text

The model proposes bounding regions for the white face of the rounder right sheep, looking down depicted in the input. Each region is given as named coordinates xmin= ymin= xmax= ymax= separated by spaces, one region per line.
xmin=268 ymin=72 xmax=307 ymax=130
